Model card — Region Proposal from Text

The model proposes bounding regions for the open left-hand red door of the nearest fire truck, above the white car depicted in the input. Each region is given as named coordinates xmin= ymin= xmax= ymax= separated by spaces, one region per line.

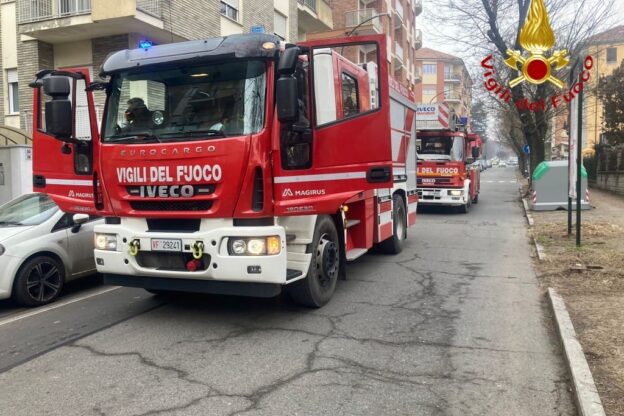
xmin=31 ymin=68 xmax=99 ymax=213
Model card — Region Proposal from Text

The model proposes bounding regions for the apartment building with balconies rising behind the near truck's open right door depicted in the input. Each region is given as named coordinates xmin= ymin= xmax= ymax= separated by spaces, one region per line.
xmin=307 ymin=0 xmax=423 ymax=90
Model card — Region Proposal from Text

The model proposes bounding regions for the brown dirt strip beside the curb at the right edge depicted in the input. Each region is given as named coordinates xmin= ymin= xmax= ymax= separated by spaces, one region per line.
xmin=531 ymin=189 xmax=624 ymax=416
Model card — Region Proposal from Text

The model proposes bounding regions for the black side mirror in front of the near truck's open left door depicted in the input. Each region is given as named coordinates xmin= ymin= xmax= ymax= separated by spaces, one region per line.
xmin=43 ymin=76 xmax=73 ymax=141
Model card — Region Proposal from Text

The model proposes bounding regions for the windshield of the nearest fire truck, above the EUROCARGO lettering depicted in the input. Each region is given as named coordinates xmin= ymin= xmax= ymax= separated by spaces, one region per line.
xmin=102 ymin=61 xmax=266 ymax=143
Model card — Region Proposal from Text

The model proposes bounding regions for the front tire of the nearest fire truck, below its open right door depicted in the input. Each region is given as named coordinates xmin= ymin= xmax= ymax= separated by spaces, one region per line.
xmin=287 ymin=215 xmax=342 ymax=308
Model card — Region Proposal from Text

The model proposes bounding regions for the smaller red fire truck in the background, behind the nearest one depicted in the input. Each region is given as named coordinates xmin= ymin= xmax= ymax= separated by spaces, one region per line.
xmin=416 ymin=103 xmax=482 ymax=213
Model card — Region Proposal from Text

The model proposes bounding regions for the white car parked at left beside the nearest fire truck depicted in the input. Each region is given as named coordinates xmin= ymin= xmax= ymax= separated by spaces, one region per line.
xmin=0 ymin=193 xmax=102 ymax=306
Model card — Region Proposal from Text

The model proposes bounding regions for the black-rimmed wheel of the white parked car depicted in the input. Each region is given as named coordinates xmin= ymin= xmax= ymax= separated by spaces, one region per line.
xmin=13 ymin=256 xmax=65 ymax=306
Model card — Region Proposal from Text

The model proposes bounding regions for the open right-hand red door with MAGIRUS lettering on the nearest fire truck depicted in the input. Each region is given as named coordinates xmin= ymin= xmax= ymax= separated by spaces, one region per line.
xmin=274 ymin=36 xmax=393 ymax=214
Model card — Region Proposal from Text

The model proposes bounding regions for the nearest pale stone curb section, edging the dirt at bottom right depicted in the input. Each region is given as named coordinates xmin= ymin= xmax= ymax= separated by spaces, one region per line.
xmin=548 ymin=288 xmax=605 ymax=416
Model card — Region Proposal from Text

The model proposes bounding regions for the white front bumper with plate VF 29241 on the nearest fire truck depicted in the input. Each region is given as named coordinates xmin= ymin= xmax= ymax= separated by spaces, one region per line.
xmin=94 ymin=219 xmax=292 ymax=293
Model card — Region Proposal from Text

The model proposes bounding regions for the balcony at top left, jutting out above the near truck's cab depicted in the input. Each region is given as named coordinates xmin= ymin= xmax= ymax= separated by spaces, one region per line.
xmin=17 ymin=0 xmax=172 ymax=43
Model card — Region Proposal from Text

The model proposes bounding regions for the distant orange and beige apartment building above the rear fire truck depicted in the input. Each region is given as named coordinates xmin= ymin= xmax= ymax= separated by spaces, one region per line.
xmin=414 ymin=48 xmax=472 ymax=117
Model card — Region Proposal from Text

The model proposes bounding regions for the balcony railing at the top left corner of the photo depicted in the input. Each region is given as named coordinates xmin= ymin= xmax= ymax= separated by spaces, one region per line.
xmin=18 ymin=0 xmax=91 ymax=24
